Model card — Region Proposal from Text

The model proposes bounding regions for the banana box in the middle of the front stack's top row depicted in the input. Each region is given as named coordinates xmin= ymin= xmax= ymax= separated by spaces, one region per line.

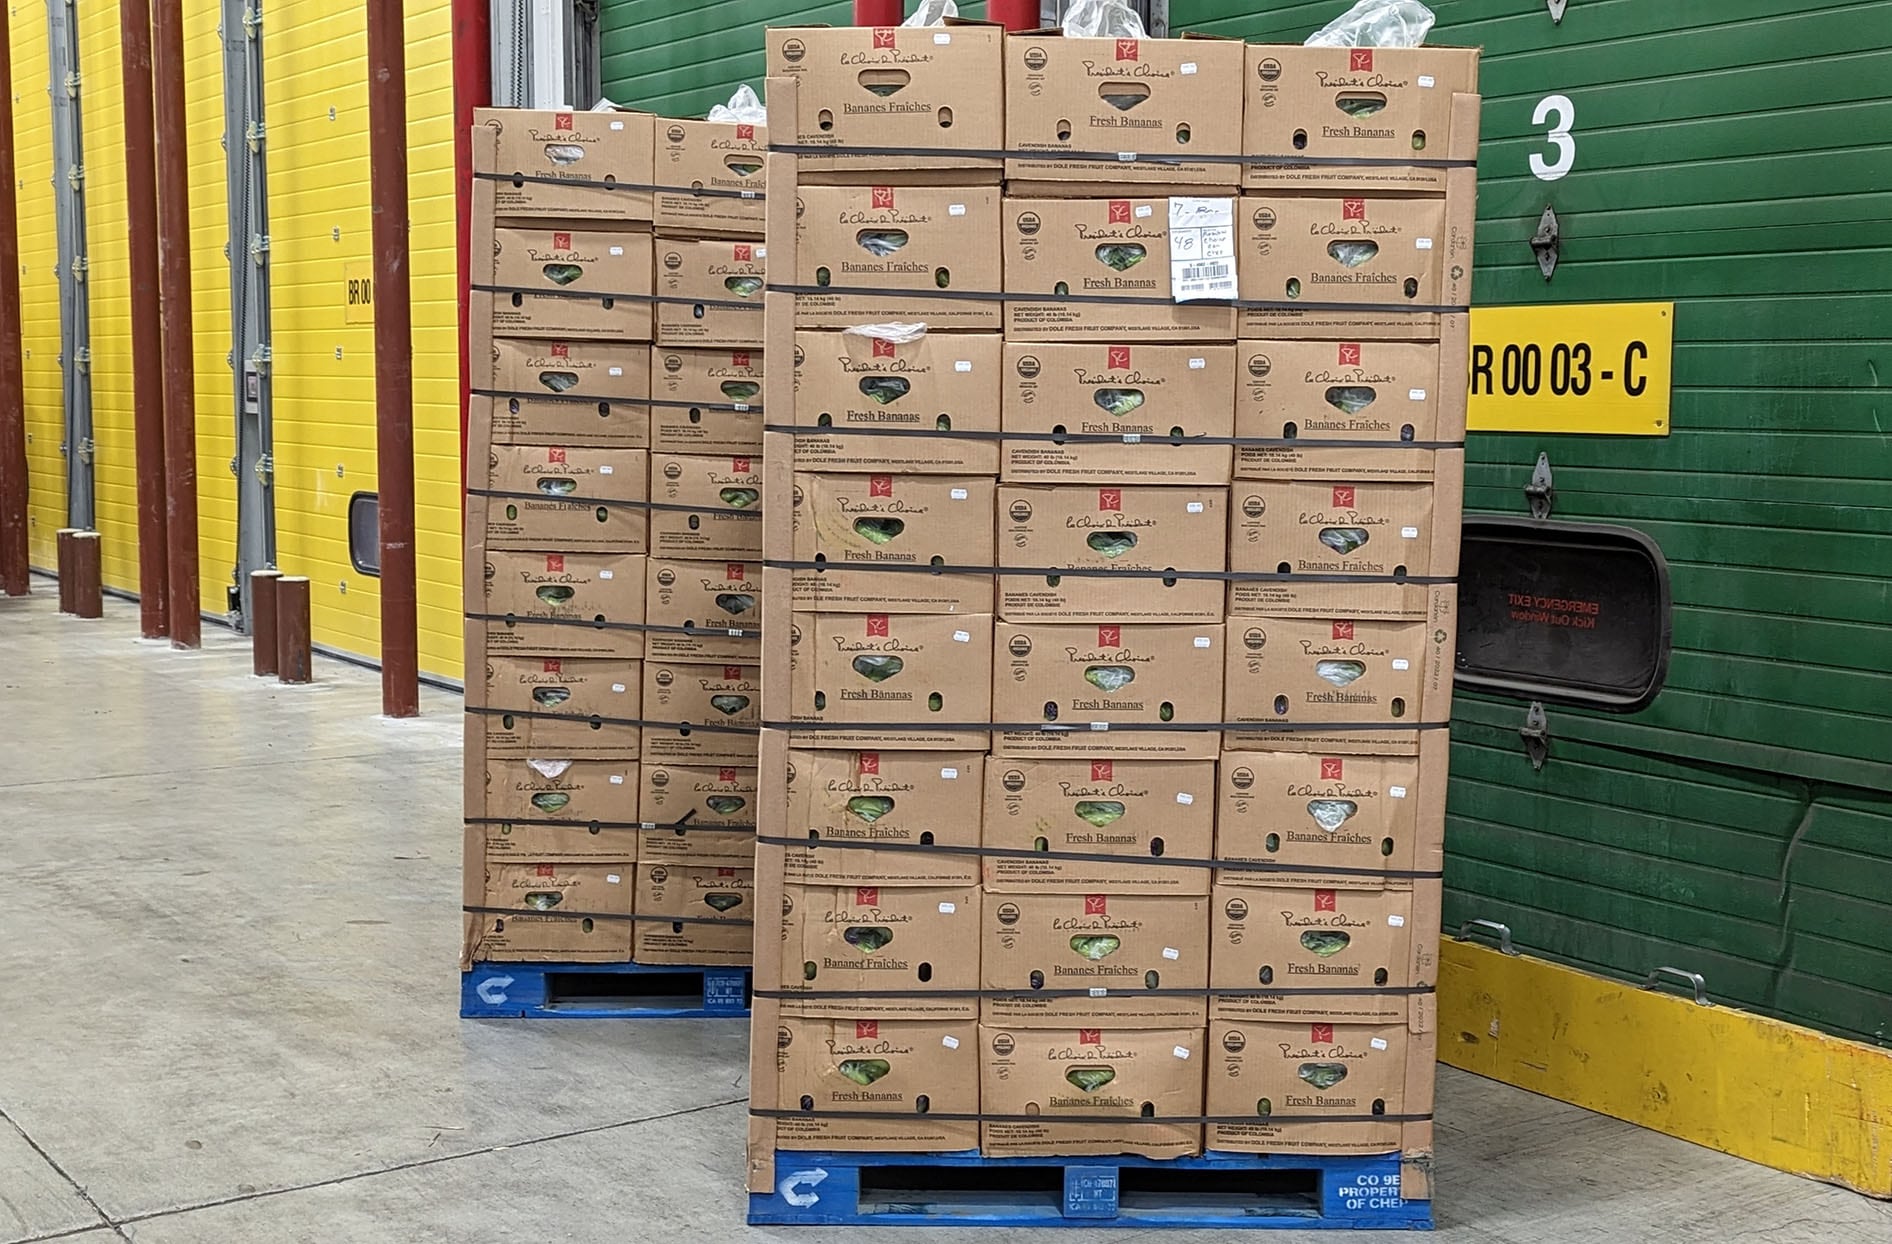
xmin=1005 ymin=30 xmax=1241 ymax=195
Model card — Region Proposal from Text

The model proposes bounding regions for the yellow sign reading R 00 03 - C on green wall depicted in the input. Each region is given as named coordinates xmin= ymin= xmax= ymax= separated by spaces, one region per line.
xmin=1466 ymin=302 xmax=1674 ymax=437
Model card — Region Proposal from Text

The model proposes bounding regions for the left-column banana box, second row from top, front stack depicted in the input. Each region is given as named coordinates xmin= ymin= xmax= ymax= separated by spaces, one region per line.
xmin=794 ymin=185 xmax=1006 ymax=331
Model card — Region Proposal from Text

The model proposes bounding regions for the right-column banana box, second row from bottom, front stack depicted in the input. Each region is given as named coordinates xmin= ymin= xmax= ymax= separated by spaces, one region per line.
xmin=1209 ymin=885 xmax=1438 ymax=1023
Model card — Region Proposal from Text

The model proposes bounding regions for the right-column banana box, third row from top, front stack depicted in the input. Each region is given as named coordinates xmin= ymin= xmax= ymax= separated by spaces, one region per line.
xmin=1235 ymin=316 xmax=1470 ymax=482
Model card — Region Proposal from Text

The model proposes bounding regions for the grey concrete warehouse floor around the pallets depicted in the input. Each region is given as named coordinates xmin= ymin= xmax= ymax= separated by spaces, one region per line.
xmin=0 ymin=580 xmax=1892 ymax=1244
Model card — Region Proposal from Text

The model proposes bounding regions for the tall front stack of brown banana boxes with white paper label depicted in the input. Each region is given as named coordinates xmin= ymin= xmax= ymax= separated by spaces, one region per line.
xmin=751 ymin=23 xmax=1476 ymax=1197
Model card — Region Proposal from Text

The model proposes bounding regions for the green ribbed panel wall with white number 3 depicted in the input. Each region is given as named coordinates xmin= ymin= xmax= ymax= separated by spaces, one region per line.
xmin=1171 ymin=0 xmax=1892 ymax=1044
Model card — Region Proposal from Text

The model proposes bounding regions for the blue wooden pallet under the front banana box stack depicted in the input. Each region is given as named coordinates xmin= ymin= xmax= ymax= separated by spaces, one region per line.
xmin=749 ymin=1149 xmax=1432 ymax=1231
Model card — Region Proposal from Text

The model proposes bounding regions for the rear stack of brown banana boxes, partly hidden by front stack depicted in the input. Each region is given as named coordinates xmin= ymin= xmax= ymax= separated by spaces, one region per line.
xmin=462 ymin=110 xmax=766 ymax=964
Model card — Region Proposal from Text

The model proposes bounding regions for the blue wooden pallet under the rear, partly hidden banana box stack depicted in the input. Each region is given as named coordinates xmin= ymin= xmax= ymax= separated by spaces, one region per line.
xmin=460 ymin=962 xmax=749 ymax=1019
